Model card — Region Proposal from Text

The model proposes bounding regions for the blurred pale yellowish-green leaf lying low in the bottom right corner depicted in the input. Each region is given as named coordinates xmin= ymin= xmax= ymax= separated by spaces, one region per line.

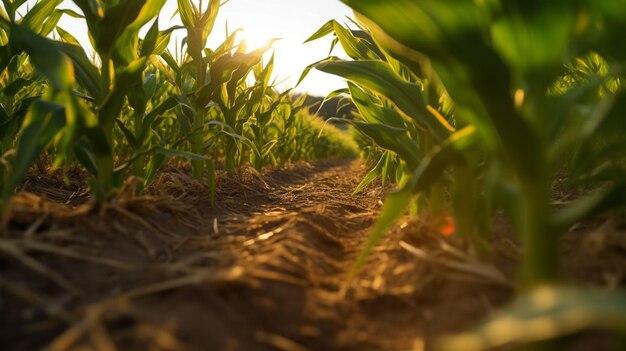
xmin=438 ymin=286 xmax=626 ymax=351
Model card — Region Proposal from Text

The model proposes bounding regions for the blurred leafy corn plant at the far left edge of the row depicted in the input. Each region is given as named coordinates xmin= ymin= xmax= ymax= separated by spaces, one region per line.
xmin=0 ymin=0 xmax=88 ymax=212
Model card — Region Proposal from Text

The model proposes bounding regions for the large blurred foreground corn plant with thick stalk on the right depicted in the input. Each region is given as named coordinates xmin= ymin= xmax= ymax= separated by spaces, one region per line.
xmin=316 ymin=0 xmax=626 ymax=350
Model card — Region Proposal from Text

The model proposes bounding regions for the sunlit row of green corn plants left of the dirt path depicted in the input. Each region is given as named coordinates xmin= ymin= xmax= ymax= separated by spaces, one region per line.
xmin=0 ymin=0 xmax=355 ymax=206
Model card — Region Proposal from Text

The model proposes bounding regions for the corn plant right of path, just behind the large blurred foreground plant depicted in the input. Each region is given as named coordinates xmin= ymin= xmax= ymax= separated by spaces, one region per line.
xmin=303 ymin=21 xmax=487 ymax=253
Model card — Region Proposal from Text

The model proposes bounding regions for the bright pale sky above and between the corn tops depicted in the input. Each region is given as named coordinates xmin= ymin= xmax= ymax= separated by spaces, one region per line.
xmin=53 ymin=0 xmax=352 ymax=95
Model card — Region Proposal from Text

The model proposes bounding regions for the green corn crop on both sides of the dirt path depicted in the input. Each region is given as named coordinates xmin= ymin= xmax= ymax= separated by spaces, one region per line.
xmin=0 ymin=0 xmax=626 ymax=350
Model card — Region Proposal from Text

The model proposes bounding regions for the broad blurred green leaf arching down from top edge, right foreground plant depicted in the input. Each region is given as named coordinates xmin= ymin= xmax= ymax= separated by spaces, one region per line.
xmin=342 ymin=0 xmax=544 ymax=179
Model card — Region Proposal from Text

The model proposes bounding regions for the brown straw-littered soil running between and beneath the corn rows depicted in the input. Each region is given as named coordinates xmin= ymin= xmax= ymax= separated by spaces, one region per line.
xmin=0 ymin=160 xmax=626 ymax=351
